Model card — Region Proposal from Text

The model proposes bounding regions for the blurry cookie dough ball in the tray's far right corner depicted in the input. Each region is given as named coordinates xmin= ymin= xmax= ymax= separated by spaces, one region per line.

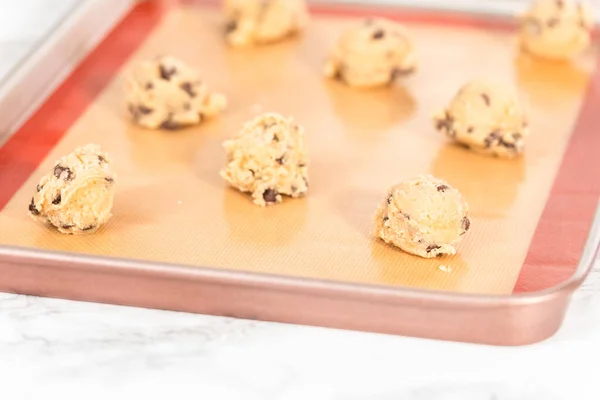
xmin=520 ymin=0 xmax=594 ymax=60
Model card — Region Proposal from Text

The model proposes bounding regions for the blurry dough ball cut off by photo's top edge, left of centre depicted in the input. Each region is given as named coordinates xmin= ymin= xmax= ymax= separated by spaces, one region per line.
xmin=225 ymin=0 xmax=309 ymax=46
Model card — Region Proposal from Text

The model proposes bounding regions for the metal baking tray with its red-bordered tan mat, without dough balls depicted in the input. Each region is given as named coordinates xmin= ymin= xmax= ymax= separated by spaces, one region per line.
xmin=0 ymin=0 xmax=600 ymax=345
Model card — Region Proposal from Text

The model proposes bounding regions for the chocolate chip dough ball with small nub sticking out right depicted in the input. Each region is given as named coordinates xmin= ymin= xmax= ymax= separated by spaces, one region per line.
xmin=125 ymin=56 xmax=227 ymax=130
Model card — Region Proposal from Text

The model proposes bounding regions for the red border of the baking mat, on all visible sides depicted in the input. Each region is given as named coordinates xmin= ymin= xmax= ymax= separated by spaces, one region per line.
xmin=0 ymin=0 xmax=600 ymax=292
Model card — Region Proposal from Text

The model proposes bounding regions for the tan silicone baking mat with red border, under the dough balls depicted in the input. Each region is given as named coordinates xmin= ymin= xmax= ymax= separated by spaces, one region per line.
xmin=0 ymin=1 xmax=600 ymax=294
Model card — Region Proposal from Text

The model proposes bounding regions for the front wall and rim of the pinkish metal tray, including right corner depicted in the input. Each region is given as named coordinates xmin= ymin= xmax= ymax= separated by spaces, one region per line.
xmin=0 ymin=200 xmax=600 ymax=346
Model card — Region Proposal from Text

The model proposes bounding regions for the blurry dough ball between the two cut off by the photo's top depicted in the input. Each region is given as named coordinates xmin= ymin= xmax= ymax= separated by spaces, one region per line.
xmin=324 ymin=19 xmax=416 ymax=87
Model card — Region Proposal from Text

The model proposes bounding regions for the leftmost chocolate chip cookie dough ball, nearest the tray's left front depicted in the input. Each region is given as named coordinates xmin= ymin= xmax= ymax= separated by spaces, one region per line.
xmin=29 ymin=144 xmax=115 ymax=234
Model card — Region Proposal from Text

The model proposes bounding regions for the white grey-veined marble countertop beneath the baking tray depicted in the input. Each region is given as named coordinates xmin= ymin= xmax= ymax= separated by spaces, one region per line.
xmin=0 ymin=0 xmax=600 ymax=400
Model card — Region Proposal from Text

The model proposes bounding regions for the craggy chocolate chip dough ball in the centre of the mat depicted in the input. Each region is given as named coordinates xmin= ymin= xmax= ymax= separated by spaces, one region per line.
xmin=221 ymin=113 xmax=308 ymax=206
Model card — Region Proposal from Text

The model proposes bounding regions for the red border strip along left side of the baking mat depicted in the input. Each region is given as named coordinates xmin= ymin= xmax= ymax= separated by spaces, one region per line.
xmin=0 ymin=2 xmax=163 ymax=210
